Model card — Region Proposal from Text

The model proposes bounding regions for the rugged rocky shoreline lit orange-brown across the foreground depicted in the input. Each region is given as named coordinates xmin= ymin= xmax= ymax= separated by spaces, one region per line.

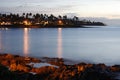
xmin=0 ymin=54 xmax=120 ymax=80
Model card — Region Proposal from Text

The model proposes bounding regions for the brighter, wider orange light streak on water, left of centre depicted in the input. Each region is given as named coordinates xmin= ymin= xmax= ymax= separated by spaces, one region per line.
xmin=23 ymin=28 xmax=29 ymax=57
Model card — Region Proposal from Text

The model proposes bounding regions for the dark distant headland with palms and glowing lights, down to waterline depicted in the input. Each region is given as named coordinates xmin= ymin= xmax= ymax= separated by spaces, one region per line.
xmin=0 ymin=13 xmax=105 ymax=28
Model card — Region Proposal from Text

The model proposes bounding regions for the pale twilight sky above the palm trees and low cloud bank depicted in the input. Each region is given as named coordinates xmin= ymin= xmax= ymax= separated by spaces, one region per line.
xmin=0 ymin=0 xmax=120 ymax=19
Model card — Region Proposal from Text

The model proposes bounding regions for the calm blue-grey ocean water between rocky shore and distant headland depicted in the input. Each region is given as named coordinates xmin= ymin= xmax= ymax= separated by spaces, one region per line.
xmin=0 ymin=26 xmax=120 ymax=64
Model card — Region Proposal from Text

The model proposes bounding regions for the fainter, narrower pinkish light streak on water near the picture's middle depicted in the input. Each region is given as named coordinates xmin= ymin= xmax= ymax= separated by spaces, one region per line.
xmin=57 ymin=28 xmax=62 ymax=58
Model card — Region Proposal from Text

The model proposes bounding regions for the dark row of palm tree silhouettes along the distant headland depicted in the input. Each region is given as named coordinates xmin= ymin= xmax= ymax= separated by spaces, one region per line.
xmin=0 ymin=13 xmax=105 ymax=27
